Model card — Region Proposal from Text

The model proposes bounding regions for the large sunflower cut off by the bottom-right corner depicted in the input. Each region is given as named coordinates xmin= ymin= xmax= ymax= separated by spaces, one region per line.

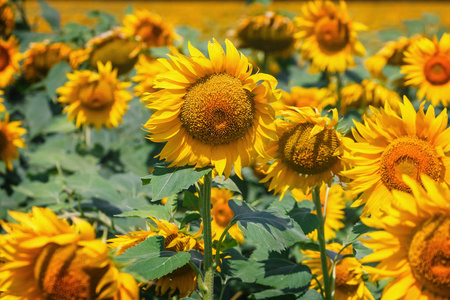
xmin=361 ymin=176 xmax=450 ymax=300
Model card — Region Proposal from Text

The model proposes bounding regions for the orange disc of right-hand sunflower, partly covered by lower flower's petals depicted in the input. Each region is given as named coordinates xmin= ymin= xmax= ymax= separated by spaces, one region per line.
xmin=380 ymin=136 xmax=441 ymax=193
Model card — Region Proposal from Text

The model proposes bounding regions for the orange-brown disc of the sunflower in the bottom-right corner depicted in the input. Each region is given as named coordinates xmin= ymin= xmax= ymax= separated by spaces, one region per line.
xmin=408 ymin=215 xmax=450 ymax=298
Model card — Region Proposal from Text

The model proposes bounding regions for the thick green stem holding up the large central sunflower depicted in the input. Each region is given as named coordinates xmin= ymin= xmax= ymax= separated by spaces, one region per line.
xmin=199 ymin=172 xmax=214 ymax=300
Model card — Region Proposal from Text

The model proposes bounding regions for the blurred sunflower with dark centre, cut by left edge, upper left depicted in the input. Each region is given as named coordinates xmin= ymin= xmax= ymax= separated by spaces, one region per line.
xmin=0 ymin=36 xmax=22 ymax=89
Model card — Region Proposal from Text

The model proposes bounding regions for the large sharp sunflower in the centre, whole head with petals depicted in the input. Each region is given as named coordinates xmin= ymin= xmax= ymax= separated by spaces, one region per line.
xmin=144 ymin=40 xmax=279 ymax=178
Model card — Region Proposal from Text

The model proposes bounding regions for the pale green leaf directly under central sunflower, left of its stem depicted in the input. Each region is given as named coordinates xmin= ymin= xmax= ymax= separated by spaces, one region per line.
xmin=147 ymin=165 xmax=211 ymax=200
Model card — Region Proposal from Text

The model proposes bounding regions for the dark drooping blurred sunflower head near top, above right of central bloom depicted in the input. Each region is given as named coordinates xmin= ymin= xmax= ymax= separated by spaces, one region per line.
xmin=235 ymin=11 xmax=298 ymax=56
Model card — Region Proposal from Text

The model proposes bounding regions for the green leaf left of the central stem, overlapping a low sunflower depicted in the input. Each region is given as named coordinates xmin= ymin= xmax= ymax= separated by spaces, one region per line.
xmin=116 ymin=236 xmax=190 ymax=280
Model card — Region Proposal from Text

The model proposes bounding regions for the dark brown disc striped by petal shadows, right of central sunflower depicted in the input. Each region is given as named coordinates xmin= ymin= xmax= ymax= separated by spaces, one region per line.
xmin=279 ymin=123 xmax=339 ymax=175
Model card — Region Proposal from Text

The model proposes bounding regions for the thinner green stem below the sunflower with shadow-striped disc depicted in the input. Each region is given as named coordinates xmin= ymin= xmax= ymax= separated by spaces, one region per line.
xmin=312 ymin=186 xmax=333 ymax=300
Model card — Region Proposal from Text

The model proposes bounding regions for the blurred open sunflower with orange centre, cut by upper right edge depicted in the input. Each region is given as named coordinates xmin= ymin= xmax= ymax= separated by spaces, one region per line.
xmin=401 ymin=33 xmax=450 ymax=106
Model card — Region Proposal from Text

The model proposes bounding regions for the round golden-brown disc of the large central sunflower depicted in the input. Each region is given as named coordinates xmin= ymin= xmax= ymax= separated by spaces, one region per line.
xmin=180 ymin=74 xmax=255 ymax=146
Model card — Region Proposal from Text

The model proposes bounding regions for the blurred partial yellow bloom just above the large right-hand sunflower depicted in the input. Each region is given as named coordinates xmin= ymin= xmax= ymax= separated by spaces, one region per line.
xmin=341 ymin=79 xmax=401 ymax=114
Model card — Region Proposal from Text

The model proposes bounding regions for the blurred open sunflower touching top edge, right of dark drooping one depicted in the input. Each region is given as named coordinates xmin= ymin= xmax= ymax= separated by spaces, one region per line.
xmin=295 ymin=0 xmax=366 ymax=73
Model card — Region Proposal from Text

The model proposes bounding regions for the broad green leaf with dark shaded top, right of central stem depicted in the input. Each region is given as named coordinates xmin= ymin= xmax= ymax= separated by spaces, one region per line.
xmin=228 ymin=199 xmax=309 ymax=252
